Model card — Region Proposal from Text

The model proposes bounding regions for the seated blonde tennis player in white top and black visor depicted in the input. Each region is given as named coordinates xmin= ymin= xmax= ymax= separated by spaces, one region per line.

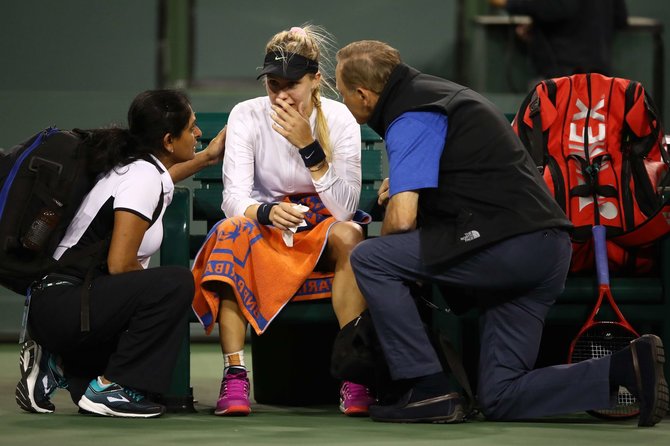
xmin=193 ymin=25 xmax=373 ymax=415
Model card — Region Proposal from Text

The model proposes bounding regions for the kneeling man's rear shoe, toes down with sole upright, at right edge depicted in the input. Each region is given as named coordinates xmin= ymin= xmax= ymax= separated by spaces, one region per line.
xmin=628 ymin=335 xmax=670 ymax=426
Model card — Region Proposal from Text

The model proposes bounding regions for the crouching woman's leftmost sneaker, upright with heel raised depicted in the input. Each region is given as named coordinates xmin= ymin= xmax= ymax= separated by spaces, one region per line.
xmin=16 ymin=340 xmax=67 ymax=413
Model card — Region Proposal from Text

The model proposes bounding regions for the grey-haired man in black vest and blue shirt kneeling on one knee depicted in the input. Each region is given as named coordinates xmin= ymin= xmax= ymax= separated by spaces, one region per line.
xmin=336 ymin=40 xmax=668 ymax=426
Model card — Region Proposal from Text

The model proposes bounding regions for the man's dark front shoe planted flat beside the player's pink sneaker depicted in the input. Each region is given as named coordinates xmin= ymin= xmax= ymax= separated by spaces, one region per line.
xmin=369 ymin=389 xmax=465 ymax=423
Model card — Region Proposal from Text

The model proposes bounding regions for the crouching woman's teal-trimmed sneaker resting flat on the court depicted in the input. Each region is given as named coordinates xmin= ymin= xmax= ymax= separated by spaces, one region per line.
xmin=78 ymin=379 xmax=165 ymax=418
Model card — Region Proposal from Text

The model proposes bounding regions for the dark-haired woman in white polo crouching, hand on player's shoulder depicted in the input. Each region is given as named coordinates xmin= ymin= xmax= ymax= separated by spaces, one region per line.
xmin=16 ymin=90 xmax=225 ymax=418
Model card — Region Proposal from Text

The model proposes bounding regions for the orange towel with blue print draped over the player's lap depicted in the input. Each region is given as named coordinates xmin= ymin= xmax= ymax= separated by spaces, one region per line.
xmin=192 ymin=196 xmax=336 ymax=334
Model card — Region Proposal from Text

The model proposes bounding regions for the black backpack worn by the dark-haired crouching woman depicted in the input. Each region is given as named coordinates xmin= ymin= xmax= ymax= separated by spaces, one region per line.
xmin=0 ymin=127 xmax=95 ymax=295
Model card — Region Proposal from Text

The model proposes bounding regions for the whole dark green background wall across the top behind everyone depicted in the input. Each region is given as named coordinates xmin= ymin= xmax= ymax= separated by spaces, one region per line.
xmin=0 ymin=0 xmax=670 ymax=148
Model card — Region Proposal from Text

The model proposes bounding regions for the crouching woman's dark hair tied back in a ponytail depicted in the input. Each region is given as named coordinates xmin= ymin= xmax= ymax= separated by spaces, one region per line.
xmin=85 ymin=90 xmax=191 ymax=174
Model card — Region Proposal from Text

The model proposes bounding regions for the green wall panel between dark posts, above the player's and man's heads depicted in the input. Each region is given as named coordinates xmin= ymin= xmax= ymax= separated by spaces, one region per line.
xmin=195 ymin=0 xmax=455 ymax=79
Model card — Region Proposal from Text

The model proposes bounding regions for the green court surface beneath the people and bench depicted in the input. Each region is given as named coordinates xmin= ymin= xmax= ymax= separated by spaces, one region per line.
xmin=0 ymin=343 xmax=670 ymax=446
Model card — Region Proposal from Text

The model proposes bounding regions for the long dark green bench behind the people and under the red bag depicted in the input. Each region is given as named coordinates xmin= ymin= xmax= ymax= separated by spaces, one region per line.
xmin=161 ymin=113 xmax=670 ymax=410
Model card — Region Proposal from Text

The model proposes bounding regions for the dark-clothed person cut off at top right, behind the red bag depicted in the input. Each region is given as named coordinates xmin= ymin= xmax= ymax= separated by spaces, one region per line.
xmin=489 ymin=0 xmax=628 ymax=79
